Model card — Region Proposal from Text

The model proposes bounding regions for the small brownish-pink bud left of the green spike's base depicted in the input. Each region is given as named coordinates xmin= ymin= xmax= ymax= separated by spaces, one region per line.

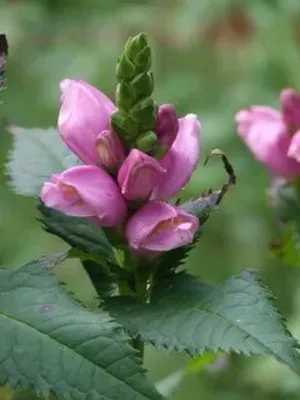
xmin=96 ymin=130 xmax=125 ymax=171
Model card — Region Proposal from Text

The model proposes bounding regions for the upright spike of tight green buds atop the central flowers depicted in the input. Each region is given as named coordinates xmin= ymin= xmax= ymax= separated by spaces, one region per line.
xmin=111 ymin=33 xmax=158 ymax=153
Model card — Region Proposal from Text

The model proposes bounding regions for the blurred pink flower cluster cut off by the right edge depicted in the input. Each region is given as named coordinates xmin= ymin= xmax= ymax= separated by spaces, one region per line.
xmin=235 ymin=89 xmax=300 ymax=179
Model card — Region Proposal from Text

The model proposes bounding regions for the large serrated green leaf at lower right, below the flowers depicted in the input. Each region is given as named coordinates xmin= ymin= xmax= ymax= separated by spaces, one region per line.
xmin=107 ymin=271 xmax=300 ymax=374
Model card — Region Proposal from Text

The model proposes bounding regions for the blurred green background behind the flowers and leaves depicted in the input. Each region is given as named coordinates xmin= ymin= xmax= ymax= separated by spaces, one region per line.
xmin=0 ymin=0 xmax=300 ymax=400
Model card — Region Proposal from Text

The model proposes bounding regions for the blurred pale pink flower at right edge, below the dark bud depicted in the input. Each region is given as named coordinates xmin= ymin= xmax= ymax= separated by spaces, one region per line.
xmin=235 ymin=106 xmax=300 ymax=177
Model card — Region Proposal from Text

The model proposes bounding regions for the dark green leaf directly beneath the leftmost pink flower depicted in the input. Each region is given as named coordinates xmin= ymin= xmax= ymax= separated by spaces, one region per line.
xmin=38 ymin=203 xmax=116 ymax=262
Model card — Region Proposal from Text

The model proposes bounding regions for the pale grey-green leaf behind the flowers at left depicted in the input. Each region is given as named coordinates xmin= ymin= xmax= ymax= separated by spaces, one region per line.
xmin=6 ymin=125 xmax=79 ymax=196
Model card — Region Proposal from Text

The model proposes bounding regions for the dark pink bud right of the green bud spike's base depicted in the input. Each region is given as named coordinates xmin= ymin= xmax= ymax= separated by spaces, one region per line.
xmin=155 ymin=104 xmax=179 ymax=149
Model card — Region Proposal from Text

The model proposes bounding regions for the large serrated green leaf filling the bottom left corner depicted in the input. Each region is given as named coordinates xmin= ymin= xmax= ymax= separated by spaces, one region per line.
xmin=0 ymin=261 xmax=161 ymax=400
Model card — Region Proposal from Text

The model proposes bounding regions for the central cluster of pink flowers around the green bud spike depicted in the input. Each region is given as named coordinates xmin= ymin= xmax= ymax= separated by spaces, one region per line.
xmin=41 ymin=79 xmax=200 ymax=252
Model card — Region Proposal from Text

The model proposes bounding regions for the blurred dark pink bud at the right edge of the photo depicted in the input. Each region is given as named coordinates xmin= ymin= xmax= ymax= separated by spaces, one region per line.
xmin=280 ymin=89 xmax=300 ymax=135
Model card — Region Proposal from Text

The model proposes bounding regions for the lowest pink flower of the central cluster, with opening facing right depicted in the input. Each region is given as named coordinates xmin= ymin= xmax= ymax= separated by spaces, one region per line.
xmin=126 ymin=201 xmax=199 ymax=252
